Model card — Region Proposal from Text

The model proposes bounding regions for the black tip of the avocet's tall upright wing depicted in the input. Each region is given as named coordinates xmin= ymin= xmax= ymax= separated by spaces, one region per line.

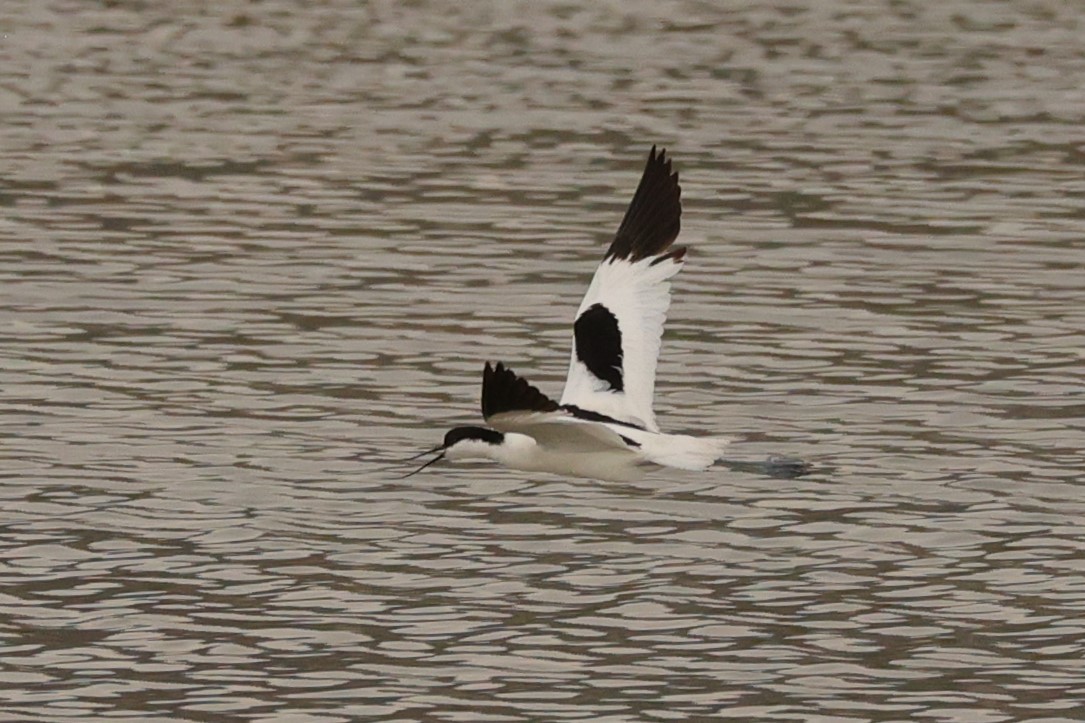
xmin=603 ymin=145 xmax=685 ymax=263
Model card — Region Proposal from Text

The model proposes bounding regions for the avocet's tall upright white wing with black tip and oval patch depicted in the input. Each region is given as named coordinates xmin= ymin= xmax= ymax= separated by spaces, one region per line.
xmin=561 ymin=145 xmax=686 ymax=431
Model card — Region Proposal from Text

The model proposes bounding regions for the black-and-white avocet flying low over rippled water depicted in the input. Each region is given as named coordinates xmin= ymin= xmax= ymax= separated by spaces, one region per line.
xmin=405 ymin=145 xmax=729 ymax=481
